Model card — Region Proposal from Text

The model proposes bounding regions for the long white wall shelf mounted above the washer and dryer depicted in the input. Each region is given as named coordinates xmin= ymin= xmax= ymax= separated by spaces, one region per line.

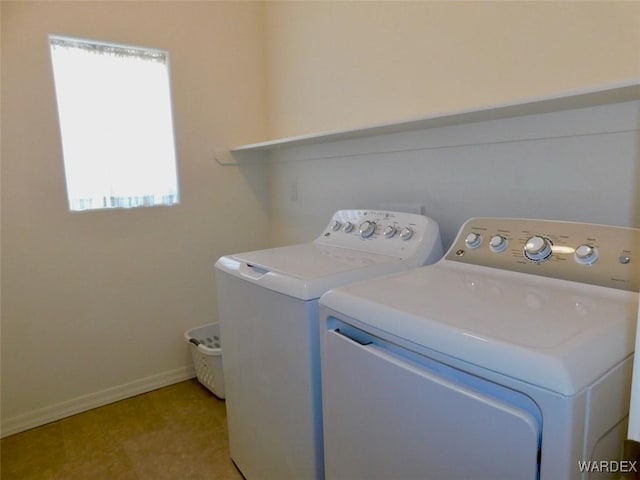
xmin=216 ymin=79 xmax=640 ymax=165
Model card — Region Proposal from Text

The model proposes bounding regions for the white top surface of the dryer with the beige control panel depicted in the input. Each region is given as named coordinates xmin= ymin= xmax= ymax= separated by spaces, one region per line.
xmin=320 ymin=260 xmax=638 ymax=395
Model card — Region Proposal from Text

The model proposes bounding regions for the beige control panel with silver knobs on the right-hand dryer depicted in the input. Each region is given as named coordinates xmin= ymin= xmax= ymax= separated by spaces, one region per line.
xmin=446 ymin=218 xmax=640 ymax=292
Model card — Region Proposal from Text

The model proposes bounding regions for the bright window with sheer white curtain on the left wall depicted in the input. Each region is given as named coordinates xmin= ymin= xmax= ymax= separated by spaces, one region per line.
xmin=49 ymin=35 xmax=178 ymax=210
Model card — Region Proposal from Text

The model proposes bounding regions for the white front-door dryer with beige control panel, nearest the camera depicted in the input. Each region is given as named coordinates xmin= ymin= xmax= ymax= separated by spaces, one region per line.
xmin=319 ymin=218 xmax=640 ymax=480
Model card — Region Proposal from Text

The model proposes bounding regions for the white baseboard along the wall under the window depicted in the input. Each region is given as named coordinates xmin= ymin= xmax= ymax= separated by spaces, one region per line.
xmin=0 ymin=365 xmax=196 ymax=437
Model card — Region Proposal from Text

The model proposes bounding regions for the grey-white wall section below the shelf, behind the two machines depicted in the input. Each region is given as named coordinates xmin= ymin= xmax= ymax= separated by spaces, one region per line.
xmin=270 ymin=101 xmax=640 ymax=248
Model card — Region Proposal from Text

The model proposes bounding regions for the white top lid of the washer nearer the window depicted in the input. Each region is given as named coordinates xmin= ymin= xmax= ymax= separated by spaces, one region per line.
xmin=216 ymin=242 xmax=409 ymax=300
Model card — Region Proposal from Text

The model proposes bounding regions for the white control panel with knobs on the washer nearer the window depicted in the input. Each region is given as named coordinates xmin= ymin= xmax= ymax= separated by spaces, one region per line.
xmin=316 ymin=210 xmax=442 ymax=258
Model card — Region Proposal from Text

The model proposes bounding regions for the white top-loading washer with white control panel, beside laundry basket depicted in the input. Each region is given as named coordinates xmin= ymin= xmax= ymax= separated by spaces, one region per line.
xmin=216 ymin=210 xmax=442 ymax=480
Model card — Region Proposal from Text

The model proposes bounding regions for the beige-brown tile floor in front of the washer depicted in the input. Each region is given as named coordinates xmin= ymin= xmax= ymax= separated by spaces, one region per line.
xmin=0 ymin=379 xmax=242 ymax=480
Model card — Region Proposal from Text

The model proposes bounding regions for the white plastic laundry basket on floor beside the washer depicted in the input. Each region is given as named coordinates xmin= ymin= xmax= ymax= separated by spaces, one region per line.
xmin=184 ymin=323 xmax=224 ymax=398
